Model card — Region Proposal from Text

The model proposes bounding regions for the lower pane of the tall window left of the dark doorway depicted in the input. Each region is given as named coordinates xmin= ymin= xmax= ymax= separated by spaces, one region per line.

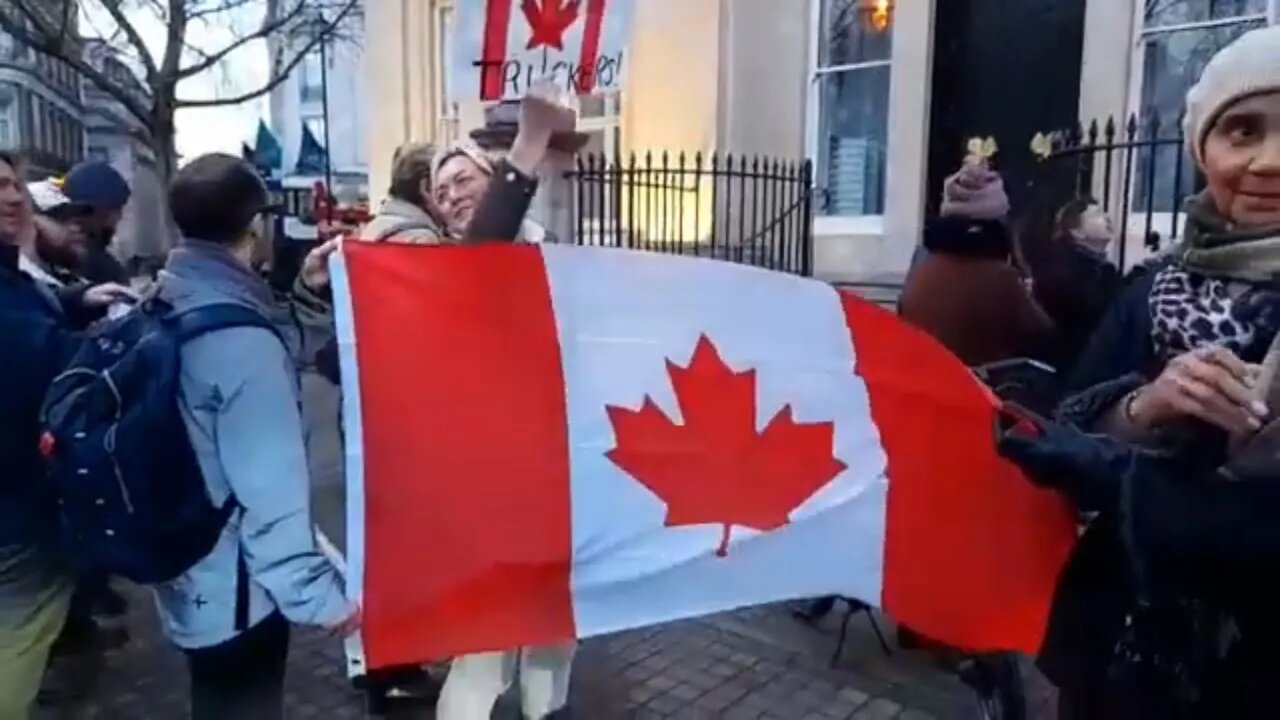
xmin=818 ymin=65 xmax=890 ymax=215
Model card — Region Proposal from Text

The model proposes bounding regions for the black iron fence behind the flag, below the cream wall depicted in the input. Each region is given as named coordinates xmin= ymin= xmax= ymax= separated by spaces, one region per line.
xmin=568 ymin=152 xmax=813 ymax=275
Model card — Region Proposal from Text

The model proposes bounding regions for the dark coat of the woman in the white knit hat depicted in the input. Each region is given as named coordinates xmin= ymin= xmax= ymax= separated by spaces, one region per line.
xmin=1014 ymin=269 xmax=1280 ymax=719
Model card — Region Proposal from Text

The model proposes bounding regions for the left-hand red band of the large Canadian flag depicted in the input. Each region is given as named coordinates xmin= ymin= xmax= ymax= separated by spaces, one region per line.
xmin=343 ymin=242 xmax=575 ymax=667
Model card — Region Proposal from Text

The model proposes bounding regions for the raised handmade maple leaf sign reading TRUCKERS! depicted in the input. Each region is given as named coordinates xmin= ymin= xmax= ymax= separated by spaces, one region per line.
xmin=451 ymin=0 xmax=635 ymax=101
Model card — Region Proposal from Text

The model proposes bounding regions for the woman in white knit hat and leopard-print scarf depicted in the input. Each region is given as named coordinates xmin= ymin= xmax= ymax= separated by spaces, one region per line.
xmin=1001 ymin=27 xmax=1280 ymax=720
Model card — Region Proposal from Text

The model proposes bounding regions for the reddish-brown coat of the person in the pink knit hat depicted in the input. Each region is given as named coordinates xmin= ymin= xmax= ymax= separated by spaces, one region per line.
xmin=899 ymin=218 xmax=1052 ymax=365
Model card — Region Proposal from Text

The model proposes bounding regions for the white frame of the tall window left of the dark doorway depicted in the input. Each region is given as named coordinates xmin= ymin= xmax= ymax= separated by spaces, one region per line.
xmin=805 ymin=0 xmax=890 ymax=236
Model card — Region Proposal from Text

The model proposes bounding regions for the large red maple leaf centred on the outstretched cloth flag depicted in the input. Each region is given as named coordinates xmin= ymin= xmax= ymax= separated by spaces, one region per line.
xmin=607 ymin=336 xmax=846 ymax=556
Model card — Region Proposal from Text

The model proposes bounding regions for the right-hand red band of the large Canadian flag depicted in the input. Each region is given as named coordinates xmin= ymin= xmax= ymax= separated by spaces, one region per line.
xmin=844 ymin=295 xmax=1075 ymax=653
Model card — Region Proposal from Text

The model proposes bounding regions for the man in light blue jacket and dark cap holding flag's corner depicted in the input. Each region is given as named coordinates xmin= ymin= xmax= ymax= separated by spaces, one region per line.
xmin=156 ymin=154 xmax=358 ymax=720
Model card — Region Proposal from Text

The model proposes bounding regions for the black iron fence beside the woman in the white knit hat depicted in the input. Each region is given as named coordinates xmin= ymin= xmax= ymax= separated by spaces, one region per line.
xmin=1029 ymin=115 xmax=1203 ymax=266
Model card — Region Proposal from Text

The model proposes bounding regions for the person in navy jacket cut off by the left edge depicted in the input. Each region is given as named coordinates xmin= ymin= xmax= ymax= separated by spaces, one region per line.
xmin=0 ymin=151 xmax=137 ymax=720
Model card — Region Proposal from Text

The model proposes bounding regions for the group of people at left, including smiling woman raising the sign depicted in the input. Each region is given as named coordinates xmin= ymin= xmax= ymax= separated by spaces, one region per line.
xmin=0 ymin=81 xmax=573 ymax=720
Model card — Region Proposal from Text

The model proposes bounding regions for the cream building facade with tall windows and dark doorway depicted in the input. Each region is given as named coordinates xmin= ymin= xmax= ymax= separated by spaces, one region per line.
xmin=366 ymin=0 xmax=1280 ymax=282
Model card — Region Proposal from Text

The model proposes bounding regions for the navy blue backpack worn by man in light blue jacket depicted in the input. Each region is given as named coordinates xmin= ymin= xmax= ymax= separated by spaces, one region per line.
xmin=41 ymin=299 xmax=279 ymax=584
